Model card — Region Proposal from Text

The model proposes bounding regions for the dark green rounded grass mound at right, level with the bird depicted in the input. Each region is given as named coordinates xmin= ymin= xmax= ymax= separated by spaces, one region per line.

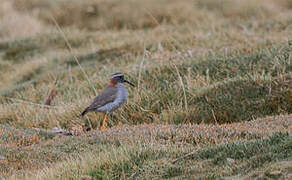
xmin=192 ymin=75 xmax=292 ymax=123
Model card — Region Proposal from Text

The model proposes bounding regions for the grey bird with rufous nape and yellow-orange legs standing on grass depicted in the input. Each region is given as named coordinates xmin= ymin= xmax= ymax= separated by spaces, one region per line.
xmin=80 ymin=72 xmax=135 ymax=130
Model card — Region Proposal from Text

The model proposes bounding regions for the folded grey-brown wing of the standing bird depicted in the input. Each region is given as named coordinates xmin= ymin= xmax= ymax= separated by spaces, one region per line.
xmin=87 ymin=86 xmax=118 ymax=111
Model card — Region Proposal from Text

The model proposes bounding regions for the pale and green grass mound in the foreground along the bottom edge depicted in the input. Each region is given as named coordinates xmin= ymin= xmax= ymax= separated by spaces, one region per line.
xmin=14 ymin=133 xmax=292 ymax=179
